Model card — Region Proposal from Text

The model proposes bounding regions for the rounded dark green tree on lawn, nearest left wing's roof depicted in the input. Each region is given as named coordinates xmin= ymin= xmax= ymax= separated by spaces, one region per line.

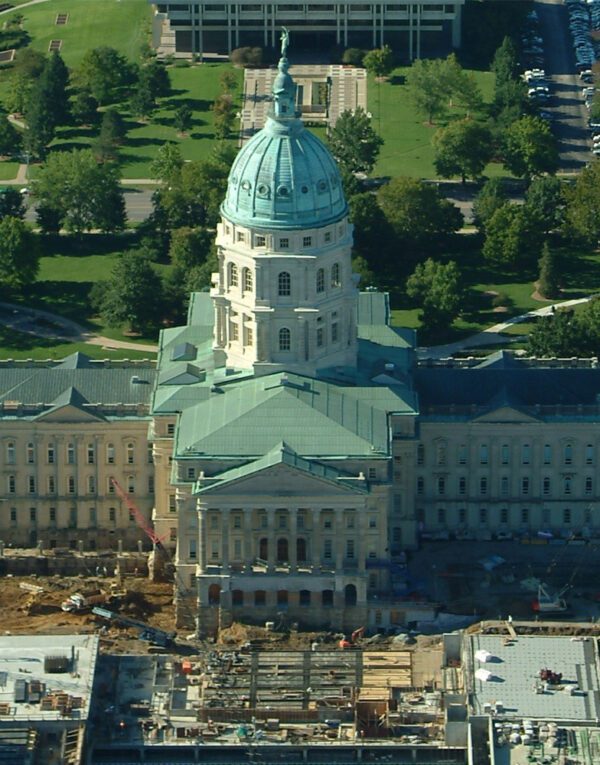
xmin=92 ymin=250 xmax=163 ymax=332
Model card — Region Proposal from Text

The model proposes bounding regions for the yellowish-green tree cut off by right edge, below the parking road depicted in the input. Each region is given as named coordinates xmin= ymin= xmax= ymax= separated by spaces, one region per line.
xmin=565 ymin=159 xmax=600 ymax=246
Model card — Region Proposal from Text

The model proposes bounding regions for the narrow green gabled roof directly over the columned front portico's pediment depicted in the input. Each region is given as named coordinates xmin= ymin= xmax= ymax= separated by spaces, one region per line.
xmin=194 ymin=441 xmax=369 ymax=494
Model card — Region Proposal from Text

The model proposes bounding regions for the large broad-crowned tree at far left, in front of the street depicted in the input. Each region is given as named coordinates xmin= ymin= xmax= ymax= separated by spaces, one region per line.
xmin=32 ymin=149 xmax=125 ymax=234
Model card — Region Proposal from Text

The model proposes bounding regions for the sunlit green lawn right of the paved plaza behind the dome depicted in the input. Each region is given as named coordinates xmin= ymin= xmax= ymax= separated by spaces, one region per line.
xmin=367 ymin=67 xmax=506 ymax=178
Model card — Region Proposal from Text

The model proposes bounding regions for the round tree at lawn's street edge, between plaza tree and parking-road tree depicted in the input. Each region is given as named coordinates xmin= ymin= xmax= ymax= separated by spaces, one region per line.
xmin=433 ymin=119 xmax=493 ymax=183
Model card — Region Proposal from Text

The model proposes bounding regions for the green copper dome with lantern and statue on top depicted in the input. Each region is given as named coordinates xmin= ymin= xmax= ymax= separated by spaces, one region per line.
xmin=221 ymin=30 xmax=348 ymax=229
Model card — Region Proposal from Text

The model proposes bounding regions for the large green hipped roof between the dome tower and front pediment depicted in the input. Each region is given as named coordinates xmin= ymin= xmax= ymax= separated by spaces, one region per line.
xmin=177 ymin=373 xmax=412 ymax=457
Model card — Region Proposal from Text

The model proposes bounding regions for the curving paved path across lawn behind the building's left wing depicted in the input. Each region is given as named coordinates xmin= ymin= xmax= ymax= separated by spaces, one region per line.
xmin=0 ymin=303 xmax=158 ymax=353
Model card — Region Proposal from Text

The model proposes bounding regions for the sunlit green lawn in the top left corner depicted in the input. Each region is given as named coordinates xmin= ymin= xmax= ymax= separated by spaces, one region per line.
xmin=0 ymin=0 xmax=152 ymax=71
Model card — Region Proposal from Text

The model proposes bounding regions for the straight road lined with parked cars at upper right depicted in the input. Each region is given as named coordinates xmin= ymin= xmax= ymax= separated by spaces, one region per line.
xmin=535 ymin=0 xmax=592 ymax=173
